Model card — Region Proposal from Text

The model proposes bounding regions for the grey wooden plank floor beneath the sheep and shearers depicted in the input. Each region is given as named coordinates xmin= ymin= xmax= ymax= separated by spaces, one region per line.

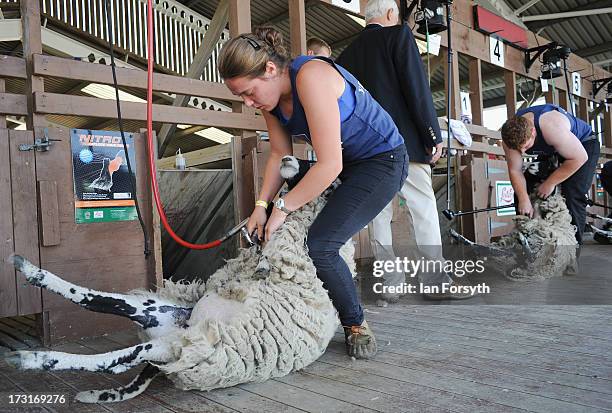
xmin=0 ymin=303 xmax=612 ymax=413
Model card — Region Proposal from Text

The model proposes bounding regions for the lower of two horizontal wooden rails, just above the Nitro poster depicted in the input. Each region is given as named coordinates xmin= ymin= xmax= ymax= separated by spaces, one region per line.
xmin=35 ymin=92 xmax=266 ymax=131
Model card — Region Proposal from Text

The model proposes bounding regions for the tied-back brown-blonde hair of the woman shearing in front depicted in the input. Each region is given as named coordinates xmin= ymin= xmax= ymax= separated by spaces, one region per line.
xmin=217 ymin=27 xmax=290 ymax=79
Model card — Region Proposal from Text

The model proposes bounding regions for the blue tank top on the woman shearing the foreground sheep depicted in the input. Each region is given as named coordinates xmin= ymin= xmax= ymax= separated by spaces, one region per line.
xmin=270 ymin=56 xmax=404 ymax=161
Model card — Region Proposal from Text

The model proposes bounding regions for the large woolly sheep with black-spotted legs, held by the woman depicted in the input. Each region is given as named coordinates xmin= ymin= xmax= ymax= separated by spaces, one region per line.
xmin=5 ymin=157 xmax=350 ymax=403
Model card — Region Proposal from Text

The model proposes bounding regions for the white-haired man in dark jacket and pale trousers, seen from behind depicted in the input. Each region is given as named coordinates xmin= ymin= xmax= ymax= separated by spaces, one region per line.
xmin=336 ymin=0 xmax=469 ymax=302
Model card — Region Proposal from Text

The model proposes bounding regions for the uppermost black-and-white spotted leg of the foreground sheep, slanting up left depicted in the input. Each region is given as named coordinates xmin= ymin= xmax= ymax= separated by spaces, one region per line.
xmin=9 ymin=255 xmax=191 ymax=329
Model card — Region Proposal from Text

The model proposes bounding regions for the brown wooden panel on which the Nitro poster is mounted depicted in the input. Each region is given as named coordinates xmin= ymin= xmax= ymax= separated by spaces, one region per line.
xmin=31 ymin=128 xmax=159 ymax=342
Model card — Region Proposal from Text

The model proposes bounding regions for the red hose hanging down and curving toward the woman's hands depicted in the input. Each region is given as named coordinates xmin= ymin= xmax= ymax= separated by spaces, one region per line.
xmin=147 ymin=0 xmax=221 ymax=250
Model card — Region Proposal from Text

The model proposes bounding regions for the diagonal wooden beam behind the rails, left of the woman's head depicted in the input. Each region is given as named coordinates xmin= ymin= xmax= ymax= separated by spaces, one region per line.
xmin=157 ymin=0 xmax=229 ymax=156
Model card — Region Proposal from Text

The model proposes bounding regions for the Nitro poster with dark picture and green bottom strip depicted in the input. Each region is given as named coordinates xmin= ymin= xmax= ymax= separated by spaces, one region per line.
xmin=70 ymin=129 xmax=138 ymax=224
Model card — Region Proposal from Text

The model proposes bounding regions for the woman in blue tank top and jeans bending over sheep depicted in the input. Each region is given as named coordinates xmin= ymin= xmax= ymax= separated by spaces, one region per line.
xmin=218 ymin=27 xmax=408 ymax=358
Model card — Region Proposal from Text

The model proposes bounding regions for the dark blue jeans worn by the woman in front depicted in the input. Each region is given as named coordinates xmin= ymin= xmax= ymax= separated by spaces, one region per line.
xmin=307 ymin=145 xmax=408 ymax=326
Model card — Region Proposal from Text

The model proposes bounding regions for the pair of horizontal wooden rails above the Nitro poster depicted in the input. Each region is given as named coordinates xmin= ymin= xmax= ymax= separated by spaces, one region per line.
xmin=0 ymin=55 xmax=265 ymax=131
